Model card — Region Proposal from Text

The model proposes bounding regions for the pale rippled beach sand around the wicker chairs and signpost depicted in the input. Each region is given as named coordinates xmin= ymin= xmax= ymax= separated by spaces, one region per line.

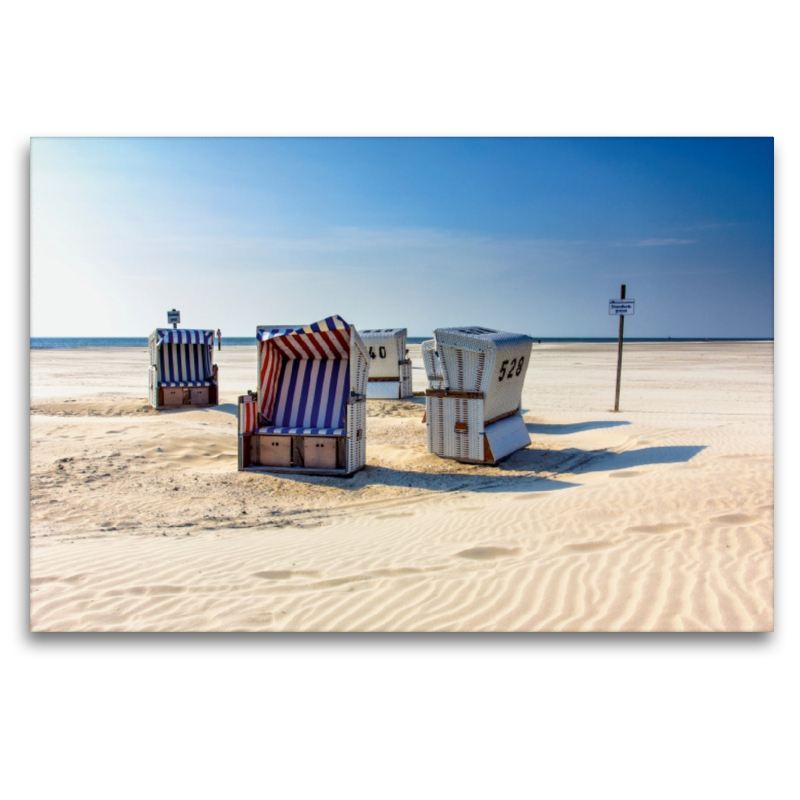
xmin=30 ymin=342 xmax=773 ymax=631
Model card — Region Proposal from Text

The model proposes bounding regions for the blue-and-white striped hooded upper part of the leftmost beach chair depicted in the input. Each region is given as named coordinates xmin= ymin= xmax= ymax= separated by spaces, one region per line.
xmin=150 ymin=328 xmax=214 ymax=387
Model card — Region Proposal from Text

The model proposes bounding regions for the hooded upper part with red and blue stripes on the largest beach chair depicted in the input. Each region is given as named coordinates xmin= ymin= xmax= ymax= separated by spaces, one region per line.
xmin=256 ymin=316 xmax=369 ymax=436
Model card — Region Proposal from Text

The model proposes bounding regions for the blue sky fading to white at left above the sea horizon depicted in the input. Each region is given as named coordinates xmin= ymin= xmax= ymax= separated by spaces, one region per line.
xmin=31 ymin=138 xmax=774 ymax=338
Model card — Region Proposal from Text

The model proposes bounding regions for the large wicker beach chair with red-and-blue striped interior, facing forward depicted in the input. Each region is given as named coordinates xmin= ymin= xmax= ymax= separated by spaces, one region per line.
xmin=239 ymin=316 xmax=370 ymax=475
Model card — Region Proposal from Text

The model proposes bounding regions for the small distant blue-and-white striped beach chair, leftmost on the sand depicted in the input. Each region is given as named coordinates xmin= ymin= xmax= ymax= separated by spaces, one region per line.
xmin=148 ymin=328 xmax=219 ymax=408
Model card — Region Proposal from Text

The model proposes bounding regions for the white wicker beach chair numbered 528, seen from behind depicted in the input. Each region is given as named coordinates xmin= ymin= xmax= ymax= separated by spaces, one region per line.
xmin=425 ymin=327 xmax=533 ymax=464
